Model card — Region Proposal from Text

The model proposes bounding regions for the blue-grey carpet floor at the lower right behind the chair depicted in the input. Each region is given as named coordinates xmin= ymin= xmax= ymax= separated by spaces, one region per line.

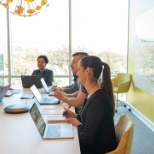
xmin=114 ymin=105 xmax=154 ymax=154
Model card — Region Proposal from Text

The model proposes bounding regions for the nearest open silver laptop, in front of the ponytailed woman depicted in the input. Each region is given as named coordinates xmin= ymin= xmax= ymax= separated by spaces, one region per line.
xmin=30 ymin=103 xmax=74 ymax=139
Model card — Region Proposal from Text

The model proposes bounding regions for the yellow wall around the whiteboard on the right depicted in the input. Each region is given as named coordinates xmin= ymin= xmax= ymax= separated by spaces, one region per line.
xmin=127 ymin=0 xmax=154 ymax=122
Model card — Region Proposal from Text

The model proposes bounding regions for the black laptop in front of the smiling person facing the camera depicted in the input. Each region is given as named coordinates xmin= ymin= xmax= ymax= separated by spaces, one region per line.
xmin=21 ymin=75 xmax=42 ymax=88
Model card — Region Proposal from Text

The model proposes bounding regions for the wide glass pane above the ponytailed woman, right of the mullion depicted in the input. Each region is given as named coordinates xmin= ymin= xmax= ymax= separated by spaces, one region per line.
xmin=72 ymin=0 xmax=128 ymax=73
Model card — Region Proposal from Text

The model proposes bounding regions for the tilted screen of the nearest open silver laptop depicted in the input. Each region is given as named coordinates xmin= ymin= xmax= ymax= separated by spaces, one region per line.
xmin=30 ymin=103 xmax=46 ymax=137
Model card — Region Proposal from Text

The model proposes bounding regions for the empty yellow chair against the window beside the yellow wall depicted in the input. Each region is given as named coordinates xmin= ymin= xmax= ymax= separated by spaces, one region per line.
xmin=111 ymin=73 xmax=132 ymax=112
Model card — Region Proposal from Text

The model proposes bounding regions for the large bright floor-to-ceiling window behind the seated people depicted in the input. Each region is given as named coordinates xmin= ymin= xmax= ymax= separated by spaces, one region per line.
xmin=0 ymin=0 xmax=128 ymax=86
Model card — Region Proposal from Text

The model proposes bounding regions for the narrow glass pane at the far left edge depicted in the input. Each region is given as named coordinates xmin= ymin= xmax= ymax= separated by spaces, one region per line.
xmin=0 ymin=6 xmax=8 ymax=79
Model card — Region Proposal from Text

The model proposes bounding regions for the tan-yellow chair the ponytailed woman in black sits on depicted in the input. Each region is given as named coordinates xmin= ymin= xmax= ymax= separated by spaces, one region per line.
xmin=106 ymin=114 xmax=134 ymax=154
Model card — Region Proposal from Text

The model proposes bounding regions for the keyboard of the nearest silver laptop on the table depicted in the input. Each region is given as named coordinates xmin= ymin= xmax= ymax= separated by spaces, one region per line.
xmin=46 ymin=125 xmax=61 ymax=138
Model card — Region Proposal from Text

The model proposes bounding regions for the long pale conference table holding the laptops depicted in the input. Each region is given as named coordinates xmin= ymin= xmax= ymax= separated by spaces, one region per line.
xmin=0 ymin=88 xmax=80 ymax=154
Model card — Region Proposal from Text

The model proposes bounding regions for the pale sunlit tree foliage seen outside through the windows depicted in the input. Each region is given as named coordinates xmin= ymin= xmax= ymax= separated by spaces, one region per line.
xmin=4 ymin=46 xmax=127 ymax=75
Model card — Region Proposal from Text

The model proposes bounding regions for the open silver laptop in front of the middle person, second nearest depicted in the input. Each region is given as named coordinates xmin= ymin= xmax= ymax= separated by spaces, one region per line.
xmin=30 ymin=85 xmax=60 ymax=105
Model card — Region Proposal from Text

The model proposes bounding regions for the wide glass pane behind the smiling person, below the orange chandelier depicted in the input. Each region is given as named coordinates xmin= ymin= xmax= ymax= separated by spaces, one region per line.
xmin=11 ymin=0 xmax=69 ymax=75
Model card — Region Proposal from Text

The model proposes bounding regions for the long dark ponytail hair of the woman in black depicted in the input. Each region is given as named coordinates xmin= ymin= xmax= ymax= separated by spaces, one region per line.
xmin=80 ymin=56 xmax=115 ymax=115
